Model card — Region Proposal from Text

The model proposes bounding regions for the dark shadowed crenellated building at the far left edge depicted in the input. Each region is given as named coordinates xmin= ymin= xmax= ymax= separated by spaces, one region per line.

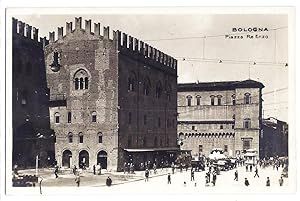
xmin=12 ymin=18 xmax=54 ymax=168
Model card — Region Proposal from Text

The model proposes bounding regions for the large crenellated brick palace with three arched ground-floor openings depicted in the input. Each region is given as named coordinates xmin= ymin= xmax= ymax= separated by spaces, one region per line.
xmin=45 ymin=17 xmax=178 ymax=170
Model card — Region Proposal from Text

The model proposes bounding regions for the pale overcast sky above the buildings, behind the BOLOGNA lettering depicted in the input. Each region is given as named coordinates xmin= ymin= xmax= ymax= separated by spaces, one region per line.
xmin=13 ymin=12 xmax=289 ymax=121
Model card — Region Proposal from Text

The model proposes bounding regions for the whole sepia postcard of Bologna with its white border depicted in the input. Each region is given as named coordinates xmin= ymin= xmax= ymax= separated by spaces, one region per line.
xmin=1 ymin=7 xmax=296 ymax=195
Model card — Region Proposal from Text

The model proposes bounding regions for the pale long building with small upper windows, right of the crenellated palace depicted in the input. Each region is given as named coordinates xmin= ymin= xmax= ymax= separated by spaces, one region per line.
xmin=177 ymin=80 xmax=264 ymax=157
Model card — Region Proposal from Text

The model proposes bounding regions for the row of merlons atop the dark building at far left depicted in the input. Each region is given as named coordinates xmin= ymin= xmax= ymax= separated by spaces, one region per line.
xmin=12 ymin=17 xmax=48 ymax=47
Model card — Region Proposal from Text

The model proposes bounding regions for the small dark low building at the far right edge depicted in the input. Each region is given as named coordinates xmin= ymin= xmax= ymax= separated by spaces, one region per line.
xmin=260 ymin=117 xmax=288 ymax=158
